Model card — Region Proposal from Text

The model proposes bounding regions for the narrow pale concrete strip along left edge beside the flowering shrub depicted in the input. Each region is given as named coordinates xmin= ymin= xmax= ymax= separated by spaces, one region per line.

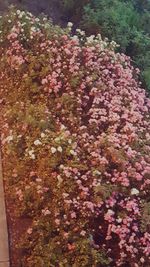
xmin=0 ymin=153 xmax=10 ymax=267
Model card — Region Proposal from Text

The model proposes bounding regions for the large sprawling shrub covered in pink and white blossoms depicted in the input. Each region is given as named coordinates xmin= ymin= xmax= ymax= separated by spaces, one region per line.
xmin=0 ymin=7 xmax=150 ymax=267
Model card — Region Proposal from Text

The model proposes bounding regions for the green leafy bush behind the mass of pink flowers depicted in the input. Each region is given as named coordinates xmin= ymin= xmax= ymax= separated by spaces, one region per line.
xmin=82 ymin=0 xmax=150 ymax=92
